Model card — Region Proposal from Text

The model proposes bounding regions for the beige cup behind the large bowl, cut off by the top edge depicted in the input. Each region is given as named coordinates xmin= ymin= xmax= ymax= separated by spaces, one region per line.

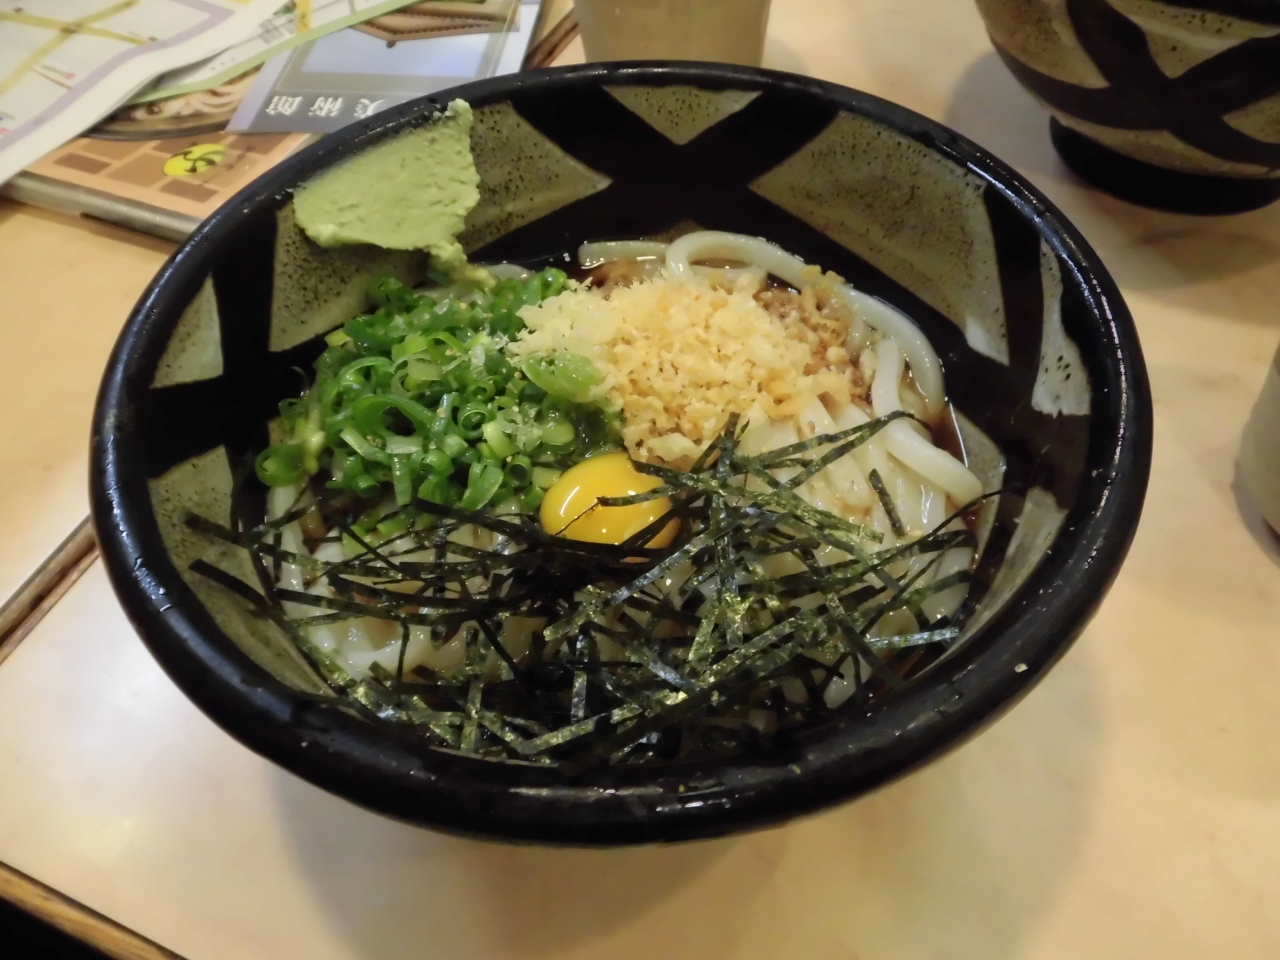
xmin=575 ymin=0 xmax=769 ymax=67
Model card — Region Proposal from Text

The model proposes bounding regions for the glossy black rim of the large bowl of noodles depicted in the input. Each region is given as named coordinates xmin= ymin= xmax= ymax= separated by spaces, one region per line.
xmin=90 ymin=61 xmax=1152 ymax=845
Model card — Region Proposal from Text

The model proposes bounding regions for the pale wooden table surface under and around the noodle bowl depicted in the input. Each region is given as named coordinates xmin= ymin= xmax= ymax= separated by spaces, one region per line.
xmin=0 ymin=0 xmax=1280 ymax=960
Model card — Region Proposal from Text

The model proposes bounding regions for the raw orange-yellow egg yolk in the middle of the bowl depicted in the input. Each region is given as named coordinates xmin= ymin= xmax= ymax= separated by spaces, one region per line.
xmin=541 ymin=453 xmax=680 ymax=548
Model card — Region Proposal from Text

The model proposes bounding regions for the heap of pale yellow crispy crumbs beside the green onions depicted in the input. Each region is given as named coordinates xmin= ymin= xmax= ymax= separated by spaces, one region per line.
xmin=507 ymin=273 xmax=863 ymax=467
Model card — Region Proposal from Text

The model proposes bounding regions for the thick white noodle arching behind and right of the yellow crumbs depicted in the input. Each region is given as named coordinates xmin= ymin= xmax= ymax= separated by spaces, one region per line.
xmin=667 ymin=230 xmax=946 ymax=417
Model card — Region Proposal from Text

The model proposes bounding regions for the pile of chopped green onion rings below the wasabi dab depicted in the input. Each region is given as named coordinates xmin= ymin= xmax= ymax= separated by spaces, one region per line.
xmin=255 ymin=269 xmax=616 ymax=529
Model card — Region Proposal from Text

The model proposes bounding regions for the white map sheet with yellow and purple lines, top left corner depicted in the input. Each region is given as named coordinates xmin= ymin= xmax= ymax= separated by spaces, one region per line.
xmin=0 ymin=0 xmax=280 ymax=182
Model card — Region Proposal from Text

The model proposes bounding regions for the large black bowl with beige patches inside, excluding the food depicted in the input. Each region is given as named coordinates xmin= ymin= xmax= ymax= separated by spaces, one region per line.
xmin=92 ymin=63 xmax=1152 ymax=845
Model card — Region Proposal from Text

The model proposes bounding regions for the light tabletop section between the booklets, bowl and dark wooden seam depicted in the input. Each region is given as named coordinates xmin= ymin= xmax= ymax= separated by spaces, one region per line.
xmin=0 ymin=200 xmax=173 ymax=624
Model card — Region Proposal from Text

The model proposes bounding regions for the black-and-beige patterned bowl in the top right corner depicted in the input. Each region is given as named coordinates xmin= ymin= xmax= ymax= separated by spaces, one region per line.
xmin=978 ymin=0 xmax=1280 ymax=214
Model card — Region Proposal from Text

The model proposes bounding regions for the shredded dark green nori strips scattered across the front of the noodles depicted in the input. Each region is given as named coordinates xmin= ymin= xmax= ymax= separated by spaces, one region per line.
xmin=188 ymin=413 xmax=974 ymax=773
